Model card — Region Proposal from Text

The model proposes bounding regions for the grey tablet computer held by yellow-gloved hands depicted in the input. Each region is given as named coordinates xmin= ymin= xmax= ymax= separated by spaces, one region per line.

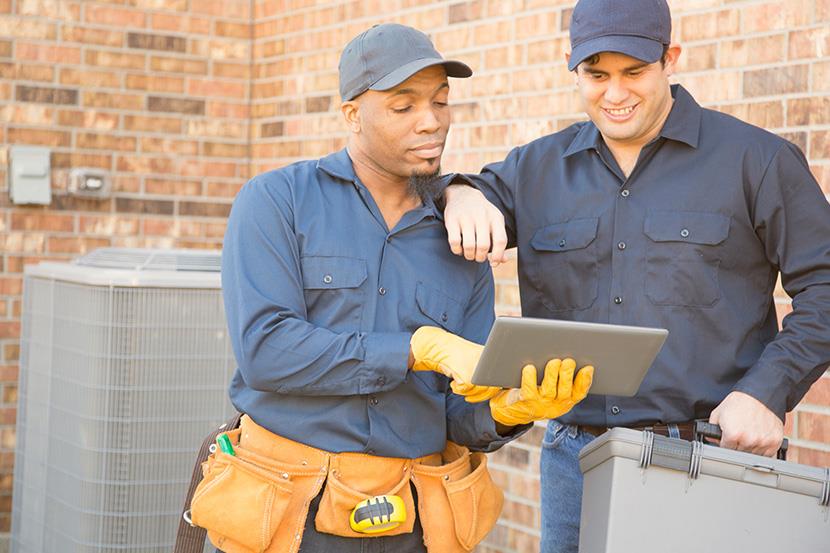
xmin=472 ymin=317 xmax=669 ymax=397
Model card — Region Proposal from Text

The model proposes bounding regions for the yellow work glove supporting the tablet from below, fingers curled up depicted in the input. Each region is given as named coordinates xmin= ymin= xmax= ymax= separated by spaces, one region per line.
xmin=490 ymin=359 xmax=594 ymax=426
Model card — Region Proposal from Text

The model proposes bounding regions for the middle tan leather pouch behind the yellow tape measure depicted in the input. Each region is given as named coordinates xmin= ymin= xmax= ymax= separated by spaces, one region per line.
xmin=314 ymin=453 xmax=415 ymax=538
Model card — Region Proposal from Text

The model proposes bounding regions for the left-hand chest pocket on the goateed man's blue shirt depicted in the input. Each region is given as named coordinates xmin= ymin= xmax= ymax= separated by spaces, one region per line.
xmin=300 ymin=256 xmax=367 ymax=332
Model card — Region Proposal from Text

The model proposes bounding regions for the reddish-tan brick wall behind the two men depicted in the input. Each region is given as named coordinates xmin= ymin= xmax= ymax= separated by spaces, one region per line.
xmin=0 ymin=0 xmax=830 ymax=551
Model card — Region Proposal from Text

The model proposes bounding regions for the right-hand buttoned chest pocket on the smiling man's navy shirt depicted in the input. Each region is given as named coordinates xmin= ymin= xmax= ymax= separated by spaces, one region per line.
xmin=643 ymin=211 xmax=731 ymax=307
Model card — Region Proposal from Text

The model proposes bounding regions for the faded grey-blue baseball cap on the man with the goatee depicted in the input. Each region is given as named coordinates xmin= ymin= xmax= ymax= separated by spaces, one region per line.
xmin=338 ymin=23 xmax=473 ymax=102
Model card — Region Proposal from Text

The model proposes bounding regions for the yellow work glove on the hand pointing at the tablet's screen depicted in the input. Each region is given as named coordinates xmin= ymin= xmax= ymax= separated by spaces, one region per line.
xmin=409 ymin=326 xmax=500 ymax=401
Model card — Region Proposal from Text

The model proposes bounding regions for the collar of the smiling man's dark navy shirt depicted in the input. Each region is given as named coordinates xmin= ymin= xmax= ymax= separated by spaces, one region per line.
xmin=562 ymin=84 xmax=703 ymax=157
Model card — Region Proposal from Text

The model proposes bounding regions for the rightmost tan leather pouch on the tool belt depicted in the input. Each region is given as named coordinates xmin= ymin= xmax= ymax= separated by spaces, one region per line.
xmin=412 ymin=442 xmax=504 ymax=553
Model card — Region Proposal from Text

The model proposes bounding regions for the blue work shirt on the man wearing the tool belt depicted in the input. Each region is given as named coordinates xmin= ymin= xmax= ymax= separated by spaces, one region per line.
xmin=222 ymin=150 xmax=521 ymax=458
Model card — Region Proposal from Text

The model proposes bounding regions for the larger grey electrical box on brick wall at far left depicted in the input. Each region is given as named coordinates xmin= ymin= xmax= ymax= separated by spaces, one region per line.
xmin=8 ymin=146 xmax=52 ymax=205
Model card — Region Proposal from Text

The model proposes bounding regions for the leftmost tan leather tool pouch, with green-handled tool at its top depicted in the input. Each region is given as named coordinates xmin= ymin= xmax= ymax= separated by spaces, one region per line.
xmin=191 ymin=430 xmax=293 ymax=553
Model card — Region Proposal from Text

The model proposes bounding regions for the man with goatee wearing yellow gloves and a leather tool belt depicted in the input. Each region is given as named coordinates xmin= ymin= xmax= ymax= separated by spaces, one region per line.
xmin=211 ymin=24 xmax=592 ymax=552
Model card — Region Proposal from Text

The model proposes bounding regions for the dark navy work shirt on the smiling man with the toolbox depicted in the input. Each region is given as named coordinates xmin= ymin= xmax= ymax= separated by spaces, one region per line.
xmin=470 ymin=86 xmax=830 ymax=426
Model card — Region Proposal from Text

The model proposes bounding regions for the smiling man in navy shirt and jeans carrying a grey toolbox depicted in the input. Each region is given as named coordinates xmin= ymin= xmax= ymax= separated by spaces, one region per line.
xmin=445 ymin=0 xmax=830 ymax=553
